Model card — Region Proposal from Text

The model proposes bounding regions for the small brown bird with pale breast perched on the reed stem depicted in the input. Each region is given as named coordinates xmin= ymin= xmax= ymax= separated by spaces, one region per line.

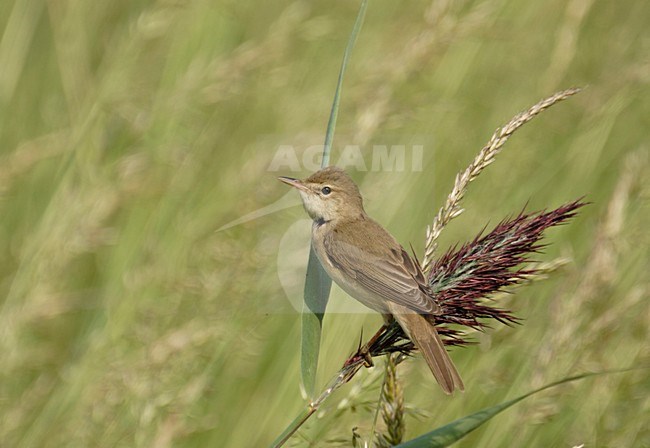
xmin=279 ymin=167 xmax=464 ymax=394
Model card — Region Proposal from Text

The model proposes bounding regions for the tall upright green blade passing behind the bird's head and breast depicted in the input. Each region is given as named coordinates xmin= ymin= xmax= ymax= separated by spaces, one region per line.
xmin=300 ymin=0 xmax=368 ymax=397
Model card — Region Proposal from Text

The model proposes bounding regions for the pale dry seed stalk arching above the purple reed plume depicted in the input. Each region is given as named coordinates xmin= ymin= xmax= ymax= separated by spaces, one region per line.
xmin=422 ymin=88 xmax=580 ymax=274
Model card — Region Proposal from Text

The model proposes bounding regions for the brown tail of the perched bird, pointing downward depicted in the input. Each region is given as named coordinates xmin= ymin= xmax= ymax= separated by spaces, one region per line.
xmin=389 ymin=303 xmax=465 ymax=394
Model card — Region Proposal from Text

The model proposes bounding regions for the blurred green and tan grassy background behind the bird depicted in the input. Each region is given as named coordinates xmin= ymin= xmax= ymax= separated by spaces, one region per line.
xmin=0 ymin=0 xmax=650 ymax=447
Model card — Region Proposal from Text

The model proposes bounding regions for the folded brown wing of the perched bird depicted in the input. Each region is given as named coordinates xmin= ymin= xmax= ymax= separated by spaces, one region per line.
xmin=324 ymin=224 xmax=440 ymax=314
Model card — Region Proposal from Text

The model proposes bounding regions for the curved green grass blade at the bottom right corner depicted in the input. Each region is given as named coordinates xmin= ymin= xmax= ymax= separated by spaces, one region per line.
xmin=397 ymin=369 xmax=632 ymax=448
